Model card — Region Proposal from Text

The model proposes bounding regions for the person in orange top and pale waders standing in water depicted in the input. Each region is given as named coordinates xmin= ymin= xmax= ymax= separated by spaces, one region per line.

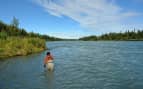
xmin=44 ymin=52 xmax=54 ymax=70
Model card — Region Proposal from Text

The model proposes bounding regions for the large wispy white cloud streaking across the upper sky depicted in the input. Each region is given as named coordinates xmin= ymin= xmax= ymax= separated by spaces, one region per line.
xmin=37 ymin=0 xmax=140 ymax=31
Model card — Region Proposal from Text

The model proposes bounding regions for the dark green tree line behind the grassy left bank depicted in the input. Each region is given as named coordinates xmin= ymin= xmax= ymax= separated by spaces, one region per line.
xmin=0 ymin=17 xmax=61 ymax=41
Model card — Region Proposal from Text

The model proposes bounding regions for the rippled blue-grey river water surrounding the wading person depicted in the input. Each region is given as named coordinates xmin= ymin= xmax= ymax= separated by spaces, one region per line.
xmin=0 ymin=41 xmax=143 ymax=89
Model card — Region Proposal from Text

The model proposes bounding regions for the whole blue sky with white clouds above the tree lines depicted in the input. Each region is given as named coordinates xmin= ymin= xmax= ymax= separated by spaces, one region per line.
xmin=0 ymin=0 xmax=143 ymax=38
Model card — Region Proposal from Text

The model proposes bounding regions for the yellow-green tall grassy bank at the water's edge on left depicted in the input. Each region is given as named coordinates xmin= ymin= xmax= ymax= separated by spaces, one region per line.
xmin=0 ymin=37 xmax=46 ymax=59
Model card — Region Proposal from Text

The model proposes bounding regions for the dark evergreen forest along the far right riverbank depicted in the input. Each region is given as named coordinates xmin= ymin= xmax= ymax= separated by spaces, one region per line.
xmin=79 ymin=29 xmax=143 ymax=41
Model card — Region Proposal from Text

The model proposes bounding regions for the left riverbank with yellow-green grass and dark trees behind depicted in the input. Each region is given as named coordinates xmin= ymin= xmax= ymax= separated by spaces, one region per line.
xmin=0 ymin=17 xmax=61 ymax=59
